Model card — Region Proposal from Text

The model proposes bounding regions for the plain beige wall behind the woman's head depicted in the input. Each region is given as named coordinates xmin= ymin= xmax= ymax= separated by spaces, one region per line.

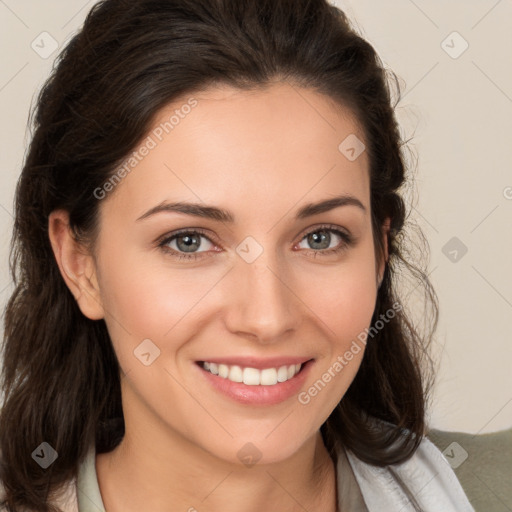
xmin=0 ymin=0 xmax=512 ymax=433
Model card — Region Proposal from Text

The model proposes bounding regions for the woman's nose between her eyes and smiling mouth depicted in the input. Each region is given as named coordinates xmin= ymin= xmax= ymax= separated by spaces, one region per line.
xmin=225 ymin=251 xmax=301 ymax=344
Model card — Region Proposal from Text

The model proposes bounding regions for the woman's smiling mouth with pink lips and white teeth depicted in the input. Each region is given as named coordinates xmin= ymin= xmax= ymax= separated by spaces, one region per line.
xmin=195 ymin=357 xmax=315 ymax=406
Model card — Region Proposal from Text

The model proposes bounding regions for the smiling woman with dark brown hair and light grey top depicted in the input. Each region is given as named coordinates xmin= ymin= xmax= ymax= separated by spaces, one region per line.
xmin=0 ymin=0 xmax=473 ymax=512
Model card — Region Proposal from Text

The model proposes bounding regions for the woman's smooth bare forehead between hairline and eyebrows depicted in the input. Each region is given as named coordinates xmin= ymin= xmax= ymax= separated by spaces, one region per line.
xmin=101 ymin=83 xmax=369 ymax=222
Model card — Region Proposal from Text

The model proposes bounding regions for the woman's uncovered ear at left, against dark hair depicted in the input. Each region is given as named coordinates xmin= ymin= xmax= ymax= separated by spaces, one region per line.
xmin=48 ymin=210 xmax=104 ymax=320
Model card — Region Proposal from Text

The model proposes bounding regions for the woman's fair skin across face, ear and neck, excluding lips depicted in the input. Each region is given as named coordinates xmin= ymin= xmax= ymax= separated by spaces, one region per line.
xmin=49 ymin=83 xmax=389 ymax=512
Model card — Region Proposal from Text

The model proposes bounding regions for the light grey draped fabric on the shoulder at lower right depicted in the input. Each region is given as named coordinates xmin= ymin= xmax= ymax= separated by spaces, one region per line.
xmin=347 ymin=420 xmax=474 ymax=512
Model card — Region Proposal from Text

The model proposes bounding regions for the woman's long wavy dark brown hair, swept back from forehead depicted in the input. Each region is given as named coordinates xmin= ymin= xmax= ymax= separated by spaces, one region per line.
xmin=0 ymin=0 xmax=438 ymax=511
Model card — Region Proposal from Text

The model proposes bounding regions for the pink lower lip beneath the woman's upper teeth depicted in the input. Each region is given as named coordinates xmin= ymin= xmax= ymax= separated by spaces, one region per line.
xmin=195 ymin=359 xmax=314 ymax=405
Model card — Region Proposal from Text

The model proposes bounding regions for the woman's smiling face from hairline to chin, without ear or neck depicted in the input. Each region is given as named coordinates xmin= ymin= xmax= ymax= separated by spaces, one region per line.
xmin=90 ymin=84 xmax=382 ymax=463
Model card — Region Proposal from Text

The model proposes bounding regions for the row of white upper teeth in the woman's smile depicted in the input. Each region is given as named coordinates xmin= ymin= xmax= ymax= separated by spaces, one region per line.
xmin=203 ymin=362 xmax=302 ymax=386
